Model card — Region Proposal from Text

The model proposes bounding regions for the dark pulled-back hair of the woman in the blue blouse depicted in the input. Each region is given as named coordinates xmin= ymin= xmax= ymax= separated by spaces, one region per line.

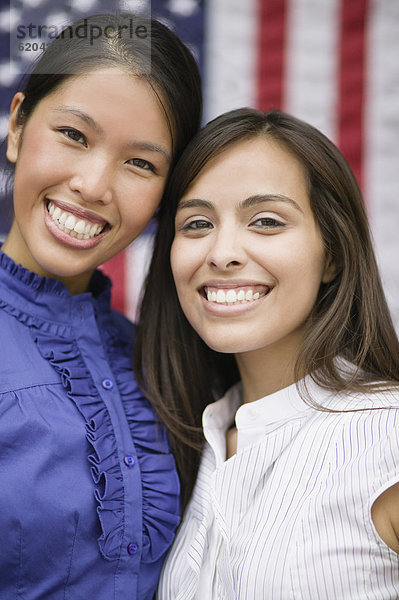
xmin=1 ymin=12 xmax=202 ymax=197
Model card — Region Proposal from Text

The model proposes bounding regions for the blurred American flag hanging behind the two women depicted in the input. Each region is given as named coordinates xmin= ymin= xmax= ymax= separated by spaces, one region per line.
xmin=0 ymin=0 xmax=399 ymax=327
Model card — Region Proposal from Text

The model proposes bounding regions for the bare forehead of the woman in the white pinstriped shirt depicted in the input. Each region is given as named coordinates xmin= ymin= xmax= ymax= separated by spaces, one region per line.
xmin=184 ymin=136 xmax=309 ymax=204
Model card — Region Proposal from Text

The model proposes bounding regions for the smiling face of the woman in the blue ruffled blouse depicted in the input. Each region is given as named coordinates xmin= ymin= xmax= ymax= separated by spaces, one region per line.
xmin=3 ymin=69 xmax=172 ymax=292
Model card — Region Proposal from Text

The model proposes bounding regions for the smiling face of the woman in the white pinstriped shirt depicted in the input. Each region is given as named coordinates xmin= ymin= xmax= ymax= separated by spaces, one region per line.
xmin=171 ymin=137 xmax=333 ymax=376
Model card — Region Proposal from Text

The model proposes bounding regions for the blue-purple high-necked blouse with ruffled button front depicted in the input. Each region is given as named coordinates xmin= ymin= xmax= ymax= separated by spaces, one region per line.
xmin=0 ymin=251 xmax=179 ymax=600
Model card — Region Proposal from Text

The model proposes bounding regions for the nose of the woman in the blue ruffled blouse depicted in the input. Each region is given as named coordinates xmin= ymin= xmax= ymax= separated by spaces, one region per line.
xmin=69 ymin=155 xmax=113 ymax=204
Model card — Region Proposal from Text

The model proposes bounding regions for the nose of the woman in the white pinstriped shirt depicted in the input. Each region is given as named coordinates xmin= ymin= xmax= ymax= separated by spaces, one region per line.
xmin=208 ymin=227 xmax=247 ymax=271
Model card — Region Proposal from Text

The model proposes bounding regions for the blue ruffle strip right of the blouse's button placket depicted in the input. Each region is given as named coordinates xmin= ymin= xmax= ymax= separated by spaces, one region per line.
xmin=104 ymin=324 xmax=180 ymax=563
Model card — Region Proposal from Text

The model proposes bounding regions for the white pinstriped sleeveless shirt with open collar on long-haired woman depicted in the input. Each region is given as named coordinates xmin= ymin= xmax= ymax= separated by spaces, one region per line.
xmin=158 ymin=383 xmax=399 ymax=600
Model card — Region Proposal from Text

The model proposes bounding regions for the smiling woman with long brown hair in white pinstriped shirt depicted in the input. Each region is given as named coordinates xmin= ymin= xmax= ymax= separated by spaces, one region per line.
xmin=136 ymin=109 xmax=399 ymax=600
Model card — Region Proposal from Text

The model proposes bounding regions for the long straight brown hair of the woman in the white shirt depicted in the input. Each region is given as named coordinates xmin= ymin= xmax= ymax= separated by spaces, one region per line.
xmin=135 ymin=109 xmax=399 ymax=500
